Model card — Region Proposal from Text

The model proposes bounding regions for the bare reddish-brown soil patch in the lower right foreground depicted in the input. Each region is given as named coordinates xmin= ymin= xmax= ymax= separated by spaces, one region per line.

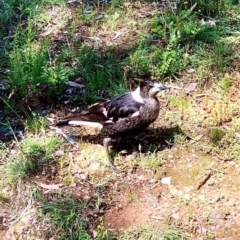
xmin=104 ymin=149 xmax=240 ymax=239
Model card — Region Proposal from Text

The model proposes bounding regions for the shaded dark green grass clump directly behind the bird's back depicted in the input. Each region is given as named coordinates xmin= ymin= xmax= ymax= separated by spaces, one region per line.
xmin=77 ymin=45 xmax=126 ymax=103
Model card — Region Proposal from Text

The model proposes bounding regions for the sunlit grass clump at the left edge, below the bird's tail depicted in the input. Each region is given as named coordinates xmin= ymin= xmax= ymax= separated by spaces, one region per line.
xmin=1 ymin=137 xmax=59 ymax=184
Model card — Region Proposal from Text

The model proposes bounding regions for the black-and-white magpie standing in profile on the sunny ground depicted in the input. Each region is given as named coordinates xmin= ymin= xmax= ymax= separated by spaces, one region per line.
xmin=56 ymin=80 xmax=168 ymax=171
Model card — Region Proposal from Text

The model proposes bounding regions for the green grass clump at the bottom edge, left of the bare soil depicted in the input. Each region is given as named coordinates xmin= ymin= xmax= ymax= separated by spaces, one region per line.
xmin=41 ymin=197 xmax=90 ymax=240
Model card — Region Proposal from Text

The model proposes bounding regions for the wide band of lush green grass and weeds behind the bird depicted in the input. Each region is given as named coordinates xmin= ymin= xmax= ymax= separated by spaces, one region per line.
xmin=2 ymin=0 xmax=237 ymax=103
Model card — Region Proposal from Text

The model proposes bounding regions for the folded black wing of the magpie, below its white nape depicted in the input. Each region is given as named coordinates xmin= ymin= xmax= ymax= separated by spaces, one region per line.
xmin=104 ymin=92 xmax=143 ymax=122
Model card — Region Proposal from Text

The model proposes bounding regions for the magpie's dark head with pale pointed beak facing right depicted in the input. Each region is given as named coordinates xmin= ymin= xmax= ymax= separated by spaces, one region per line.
xmin=140 ymin=80 xmax=168 ymax=97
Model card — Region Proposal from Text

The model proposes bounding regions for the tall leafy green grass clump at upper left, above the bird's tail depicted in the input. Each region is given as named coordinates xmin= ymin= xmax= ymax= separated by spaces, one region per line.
xmin=8 ymin=25 xmax=73 ymax=96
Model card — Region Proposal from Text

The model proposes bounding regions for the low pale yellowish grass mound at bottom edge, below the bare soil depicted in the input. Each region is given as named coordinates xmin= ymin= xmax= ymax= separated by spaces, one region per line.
xmin=118 ymin=225 xmax=190 ymax=240
